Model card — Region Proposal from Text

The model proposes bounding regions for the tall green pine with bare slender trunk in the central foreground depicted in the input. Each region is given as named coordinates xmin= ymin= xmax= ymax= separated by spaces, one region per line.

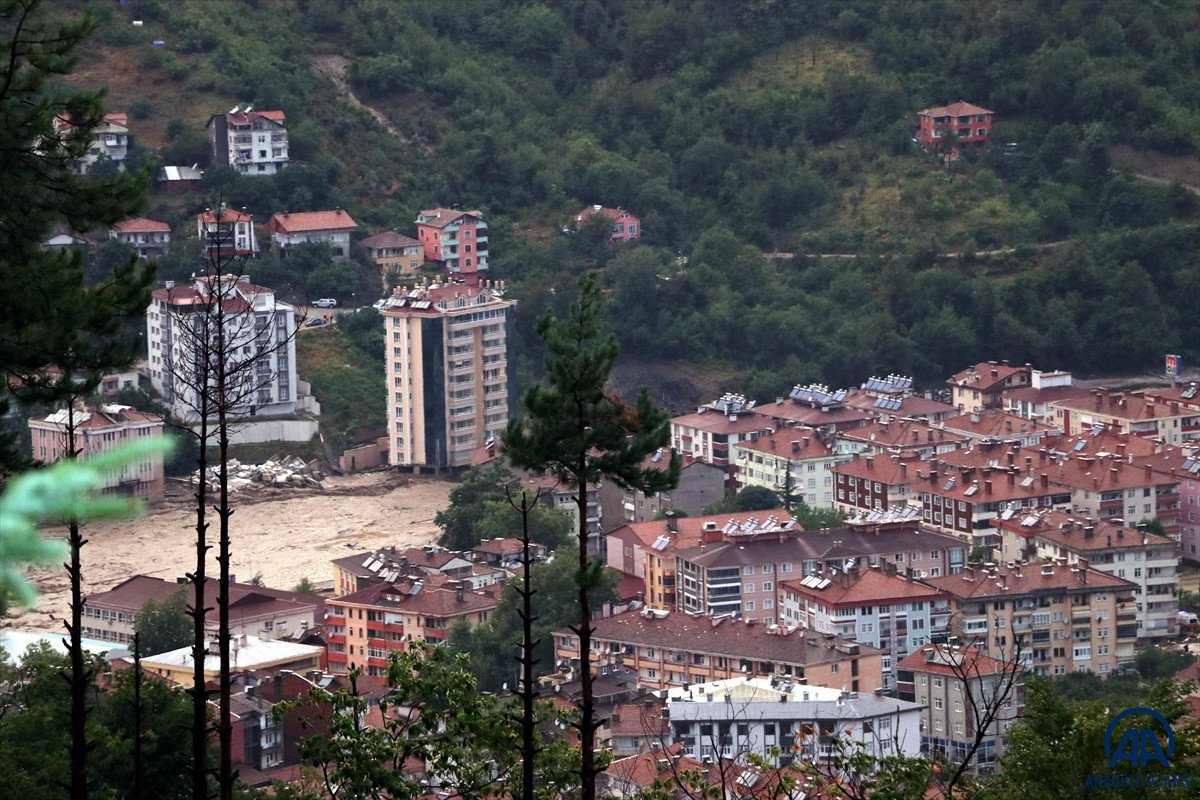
xmin=503 ymin=273 xmax=680 ymax=800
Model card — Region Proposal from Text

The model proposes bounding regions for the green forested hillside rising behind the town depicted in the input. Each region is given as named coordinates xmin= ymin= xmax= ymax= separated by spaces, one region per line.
xmin=72 ymin=0 xmax=1200 ymax=401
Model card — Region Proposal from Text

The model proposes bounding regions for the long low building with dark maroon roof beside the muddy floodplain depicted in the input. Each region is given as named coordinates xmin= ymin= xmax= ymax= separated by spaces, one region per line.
xmin=83 ymin=575 xmax=325 ymax=644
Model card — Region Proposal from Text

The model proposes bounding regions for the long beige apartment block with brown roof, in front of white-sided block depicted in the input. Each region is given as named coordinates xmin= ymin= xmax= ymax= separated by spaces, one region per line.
xmin=924 ymin=559 xmax=1138 ymax=675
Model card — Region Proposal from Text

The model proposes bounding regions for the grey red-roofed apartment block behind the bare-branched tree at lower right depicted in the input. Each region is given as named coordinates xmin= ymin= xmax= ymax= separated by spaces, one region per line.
xmin=896 ymin=644 xmax=1025 ymax=774
